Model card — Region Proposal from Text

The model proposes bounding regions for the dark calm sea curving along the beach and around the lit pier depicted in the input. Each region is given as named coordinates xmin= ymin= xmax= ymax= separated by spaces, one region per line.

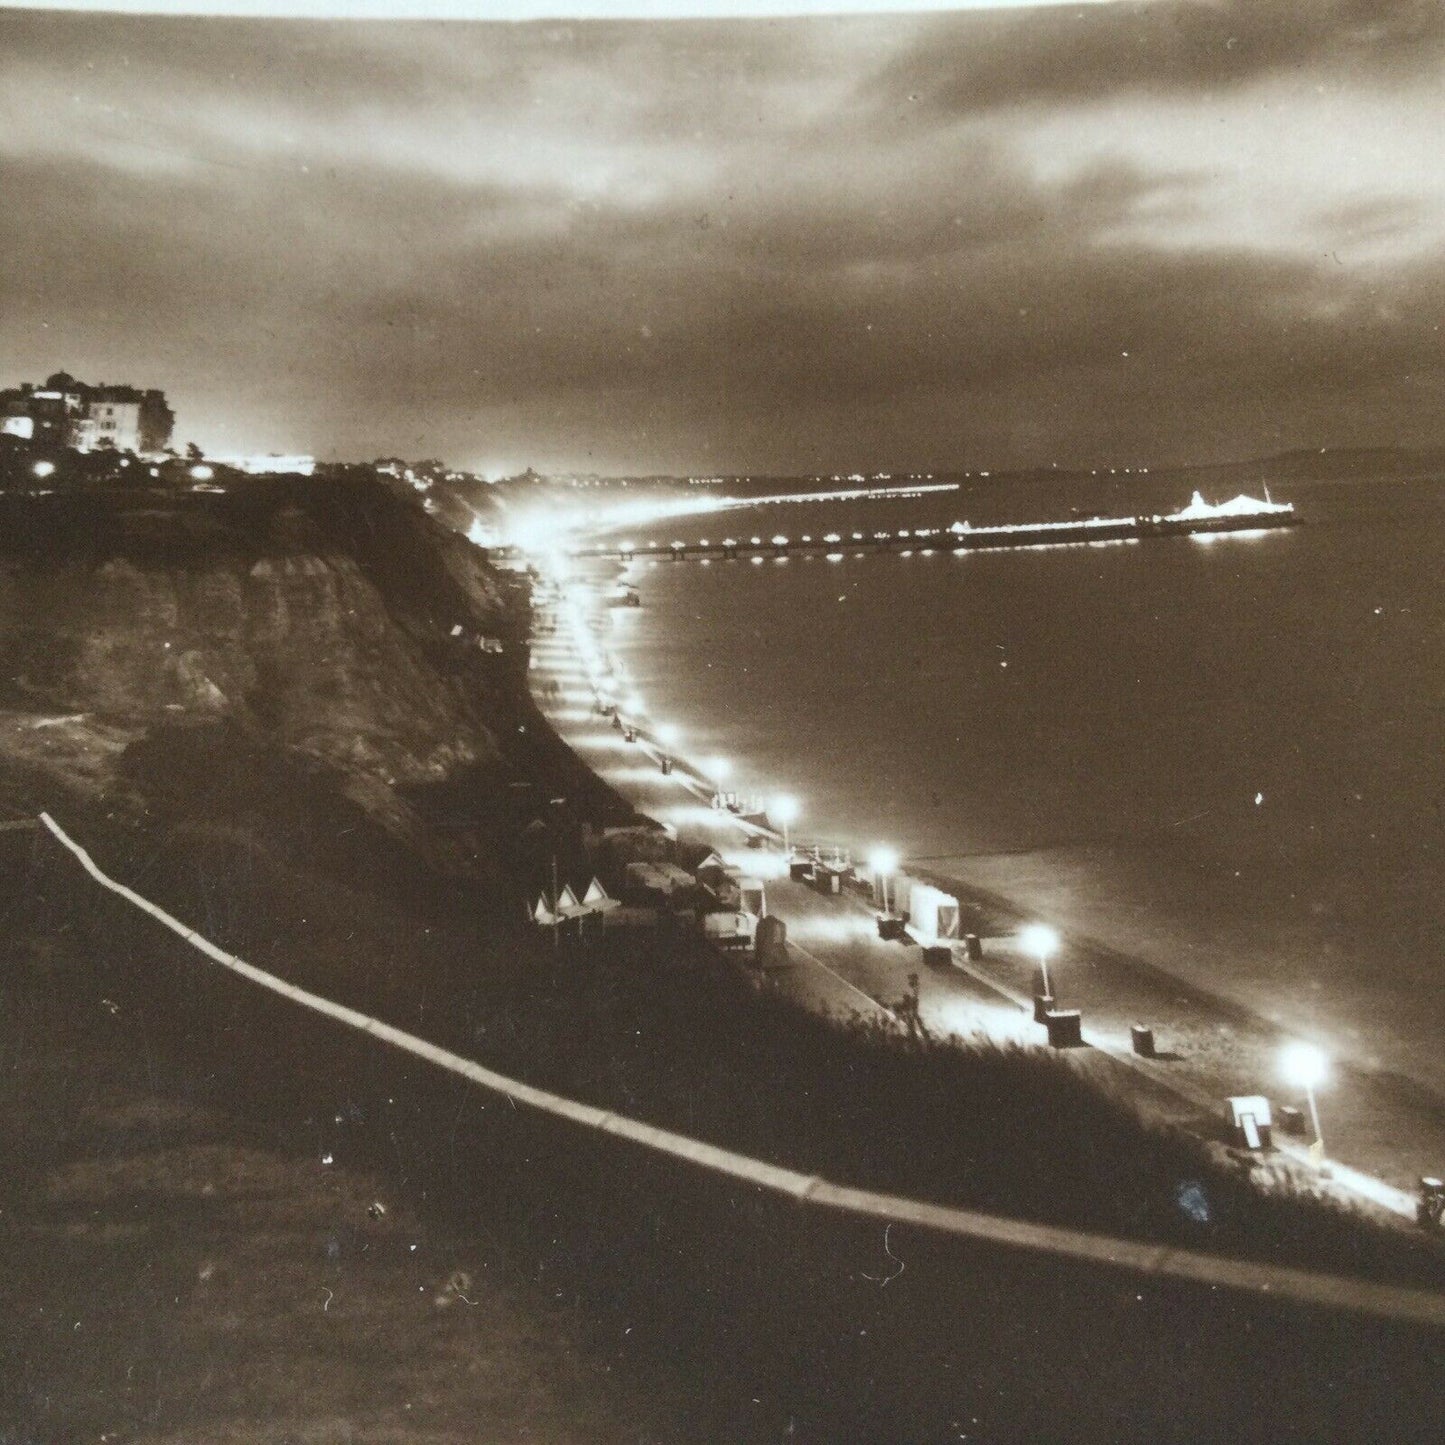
xmin=614 ymin=483 xmax=1445 ymax=1094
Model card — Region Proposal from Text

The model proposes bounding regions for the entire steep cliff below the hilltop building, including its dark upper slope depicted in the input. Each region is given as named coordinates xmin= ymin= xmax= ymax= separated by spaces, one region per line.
xmin=0 ymin=480 xmax=531 ymax=868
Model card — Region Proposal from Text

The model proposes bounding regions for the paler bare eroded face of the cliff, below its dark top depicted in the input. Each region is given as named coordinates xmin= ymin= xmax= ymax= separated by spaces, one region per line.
xmin=31 ymin=555 xmax=496 ymax=782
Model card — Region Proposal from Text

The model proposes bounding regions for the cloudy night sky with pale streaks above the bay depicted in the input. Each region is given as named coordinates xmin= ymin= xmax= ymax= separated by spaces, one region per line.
xmin=0 ymin=0 xmax=1445 ymax=475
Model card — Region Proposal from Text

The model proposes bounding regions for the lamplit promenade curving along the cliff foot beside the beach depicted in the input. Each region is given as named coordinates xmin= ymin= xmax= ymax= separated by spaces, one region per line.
xmin=532 ymin=623 xmax=1445 ymax=1218
